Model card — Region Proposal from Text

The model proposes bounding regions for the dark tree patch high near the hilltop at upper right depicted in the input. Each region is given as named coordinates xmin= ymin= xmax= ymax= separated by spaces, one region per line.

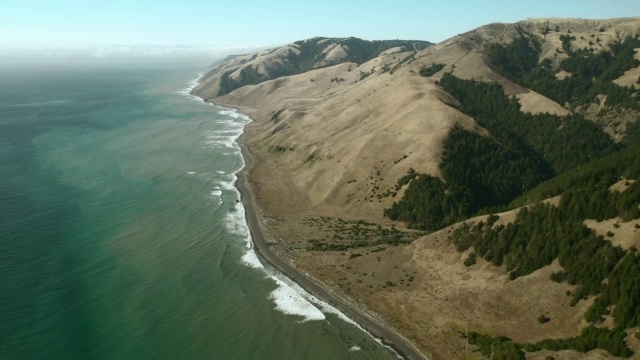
xmin=489 ymin=32 xmax=640 ymax=110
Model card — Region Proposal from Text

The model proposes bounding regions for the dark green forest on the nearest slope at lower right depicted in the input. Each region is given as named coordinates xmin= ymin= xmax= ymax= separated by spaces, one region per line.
xmin=450 ymin=144 xmax=640 ymax=358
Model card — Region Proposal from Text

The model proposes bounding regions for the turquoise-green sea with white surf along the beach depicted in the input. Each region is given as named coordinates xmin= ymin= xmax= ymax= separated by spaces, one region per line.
xmin=0 ymin=64 xmax=394 ymax=359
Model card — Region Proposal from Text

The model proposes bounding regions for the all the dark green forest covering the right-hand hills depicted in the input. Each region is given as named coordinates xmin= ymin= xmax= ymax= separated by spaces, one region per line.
xmin=385 ymin=33 xmax=640 ymax=359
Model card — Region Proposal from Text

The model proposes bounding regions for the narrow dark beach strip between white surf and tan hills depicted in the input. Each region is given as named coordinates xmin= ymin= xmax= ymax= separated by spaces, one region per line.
xmin=230 ymin=117 xmax=429 ymax=360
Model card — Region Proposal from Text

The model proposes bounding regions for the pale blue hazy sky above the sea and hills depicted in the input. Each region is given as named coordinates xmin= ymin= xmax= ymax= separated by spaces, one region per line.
xmin=0 ymin=0 xmax=640 ymax=57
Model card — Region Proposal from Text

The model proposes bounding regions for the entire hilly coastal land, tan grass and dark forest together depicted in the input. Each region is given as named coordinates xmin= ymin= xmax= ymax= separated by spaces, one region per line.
xmin=195 ymin=18 xmax=640 ymax=359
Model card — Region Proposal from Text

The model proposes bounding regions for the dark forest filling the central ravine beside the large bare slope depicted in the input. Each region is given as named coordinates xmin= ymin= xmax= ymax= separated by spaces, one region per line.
xmin=385 ymin=73 xmax=620 ymax=230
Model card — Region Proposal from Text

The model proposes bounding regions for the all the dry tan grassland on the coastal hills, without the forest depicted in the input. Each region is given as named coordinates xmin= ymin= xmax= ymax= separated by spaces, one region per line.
xmin=195 ymin=18 xmax=640 ymax=359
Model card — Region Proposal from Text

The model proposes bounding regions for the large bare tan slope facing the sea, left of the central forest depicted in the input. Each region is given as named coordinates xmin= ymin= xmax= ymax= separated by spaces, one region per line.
xmin=195 ymin=42 xmax=474 ymax=219
